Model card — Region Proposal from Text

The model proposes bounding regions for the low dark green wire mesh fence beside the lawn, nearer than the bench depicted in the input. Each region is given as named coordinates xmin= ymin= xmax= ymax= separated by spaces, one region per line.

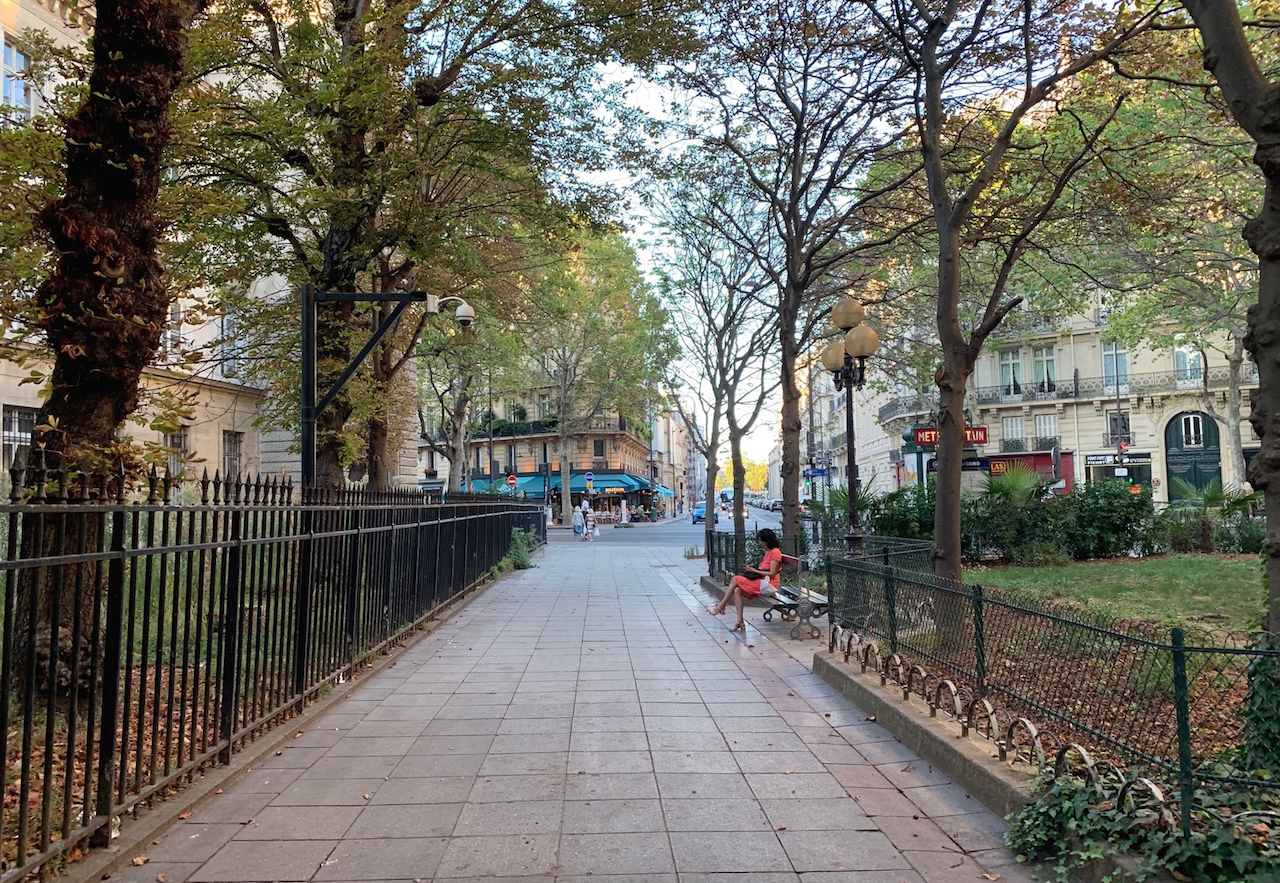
xmin=826 ymin=557 xmax=1280 ymax=831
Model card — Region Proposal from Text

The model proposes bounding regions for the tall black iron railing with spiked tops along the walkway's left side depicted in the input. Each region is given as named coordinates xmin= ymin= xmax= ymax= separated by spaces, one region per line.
xmin=0 ymin=460 xmax=545 ymax=883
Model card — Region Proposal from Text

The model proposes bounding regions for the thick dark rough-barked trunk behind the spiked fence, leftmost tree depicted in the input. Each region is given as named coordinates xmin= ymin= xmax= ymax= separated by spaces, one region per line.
xmin=14 ymin=0 xmax=202 ymax=682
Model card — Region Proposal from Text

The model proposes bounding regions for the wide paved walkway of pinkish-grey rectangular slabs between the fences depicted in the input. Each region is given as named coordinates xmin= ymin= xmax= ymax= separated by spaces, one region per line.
xmin=111 ymin=544 xmax=1032 ymax=883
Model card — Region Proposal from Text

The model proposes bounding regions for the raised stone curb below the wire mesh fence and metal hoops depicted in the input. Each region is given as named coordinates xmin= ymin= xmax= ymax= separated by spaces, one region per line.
xmin=813 ymin=650 xmax=1037 ymax=818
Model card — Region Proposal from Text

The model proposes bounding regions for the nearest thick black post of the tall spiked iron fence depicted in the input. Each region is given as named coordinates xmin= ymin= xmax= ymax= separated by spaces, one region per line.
xmin=91 ymin=499 xmax=124 ymax=846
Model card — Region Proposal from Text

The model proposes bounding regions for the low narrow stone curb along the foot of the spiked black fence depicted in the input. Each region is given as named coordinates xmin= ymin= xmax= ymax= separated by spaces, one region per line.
xmin=56 ymin=546 xmax=535 ymax=883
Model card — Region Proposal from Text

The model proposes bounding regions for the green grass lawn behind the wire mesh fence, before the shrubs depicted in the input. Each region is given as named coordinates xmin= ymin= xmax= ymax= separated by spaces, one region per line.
xmin=964 ymin=554 xmax=1266 ymax=630
